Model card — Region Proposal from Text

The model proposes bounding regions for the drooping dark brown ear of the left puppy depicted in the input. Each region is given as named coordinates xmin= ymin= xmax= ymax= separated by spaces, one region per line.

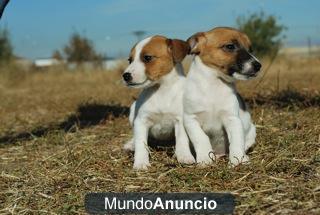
xmin=167 ymin=39 xmax=190 ymax=63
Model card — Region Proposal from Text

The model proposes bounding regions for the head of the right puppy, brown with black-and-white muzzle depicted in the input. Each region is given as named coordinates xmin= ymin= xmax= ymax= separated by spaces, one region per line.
xmin=188 ymin=27 xmax=261 ymax=80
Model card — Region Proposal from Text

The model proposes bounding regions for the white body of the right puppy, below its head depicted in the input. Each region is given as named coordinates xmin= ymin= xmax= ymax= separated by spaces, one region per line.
xmin=183 ymin=56 xmax=256 ymax=166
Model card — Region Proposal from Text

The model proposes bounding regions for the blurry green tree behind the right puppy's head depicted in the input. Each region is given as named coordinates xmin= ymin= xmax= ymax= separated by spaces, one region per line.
xmin=237 ymin=12 xmax=286 ymax=57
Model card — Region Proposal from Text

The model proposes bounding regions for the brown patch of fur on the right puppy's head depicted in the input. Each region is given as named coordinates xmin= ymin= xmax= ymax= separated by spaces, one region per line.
xmin=188 ymin=27 xmax=251 ymax=74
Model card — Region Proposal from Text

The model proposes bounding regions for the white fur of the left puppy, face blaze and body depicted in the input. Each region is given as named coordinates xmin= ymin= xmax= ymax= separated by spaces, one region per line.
xmin=124 ymin=38 xmax=195 ymax=170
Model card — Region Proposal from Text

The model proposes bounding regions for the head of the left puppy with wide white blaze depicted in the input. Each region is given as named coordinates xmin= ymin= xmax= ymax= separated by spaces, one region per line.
xmin=123 ymin=36 xmax=189 ymax=88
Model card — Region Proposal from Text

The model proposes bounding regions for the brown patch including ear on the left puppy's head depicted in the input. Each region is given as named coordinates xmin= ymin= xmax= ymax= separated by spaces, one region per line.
xmin=140 ymin=36 xmax=189 ymax=81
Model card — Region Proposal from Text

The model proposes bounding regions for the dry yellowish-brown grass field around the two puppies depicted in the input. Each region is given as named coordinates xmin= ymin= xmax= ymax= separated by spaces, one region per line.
xmin=0 ymin=57 xmax=320 ymax=214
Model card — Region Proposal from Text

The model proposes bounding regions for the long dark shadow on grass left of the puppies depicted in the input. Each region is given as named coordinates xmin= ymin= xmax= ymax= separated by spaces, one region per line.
xmin=0 ymin=103 xmax=129 ymax=144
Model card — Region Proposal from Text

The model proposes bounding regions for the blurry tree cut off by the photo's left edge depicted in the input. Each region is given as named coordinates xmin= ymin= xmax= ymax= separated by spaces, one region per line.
xmin=0 ymin=29 xmax=13 ymax=62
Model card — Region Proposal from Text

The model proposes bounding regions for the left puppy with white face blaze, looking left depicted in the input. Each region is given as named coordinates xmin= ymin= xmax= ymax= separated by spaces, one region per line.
xmin=123 ymin=36 xmax=195 ymax=169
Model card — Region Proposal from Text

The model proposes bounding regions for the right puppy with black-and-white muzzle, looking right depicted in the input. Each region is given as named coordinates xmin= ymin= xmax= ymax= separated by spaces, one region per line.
xmin=183 ymin=27 xmax=261 ymax=166
